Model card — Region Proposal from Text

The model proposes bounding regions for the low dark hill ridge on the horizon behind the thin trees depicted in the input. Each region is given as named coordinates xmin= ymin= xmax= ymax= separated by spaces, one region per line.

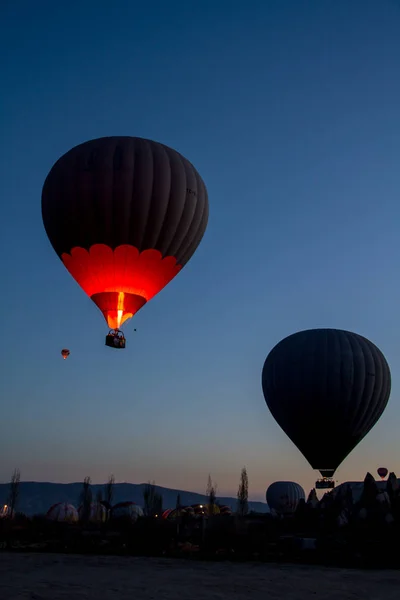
xmin=0 ymin=481 xmax=268 ymax=516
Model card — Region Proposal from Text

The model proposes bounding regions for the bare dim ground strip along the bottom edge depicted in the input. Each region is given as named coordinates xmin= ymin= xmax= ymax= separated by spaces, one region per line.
xmin=0 ymin=552 xmax=400 ymax=600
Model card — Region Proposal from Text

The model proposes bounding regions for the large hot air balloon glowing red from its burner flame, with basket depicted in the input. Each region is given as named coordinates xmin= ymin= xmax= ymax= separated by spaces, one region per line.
xmin=42 ymin=137 xmax=208 ymax=348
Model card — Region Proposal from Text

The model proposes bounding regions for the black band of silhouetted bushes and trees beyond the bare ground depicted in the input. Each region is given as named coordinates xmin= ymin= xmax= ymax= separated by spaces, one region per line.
xmin=0 ymin=473 xmax=400 ymax=567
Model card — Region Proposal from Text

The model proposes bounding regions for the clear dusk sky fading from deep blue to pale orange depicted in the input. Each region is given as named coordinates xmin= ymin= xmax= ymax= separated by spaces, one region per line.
xmin=0 ymin=0 xmax=400 ymax=498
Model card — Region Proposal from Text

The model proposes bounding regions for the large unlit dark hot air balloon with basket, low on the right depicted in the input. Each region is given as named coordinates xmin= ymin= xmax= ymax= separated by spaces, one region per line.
xmin=262 ymin=329 xmax=391 ymax=487
